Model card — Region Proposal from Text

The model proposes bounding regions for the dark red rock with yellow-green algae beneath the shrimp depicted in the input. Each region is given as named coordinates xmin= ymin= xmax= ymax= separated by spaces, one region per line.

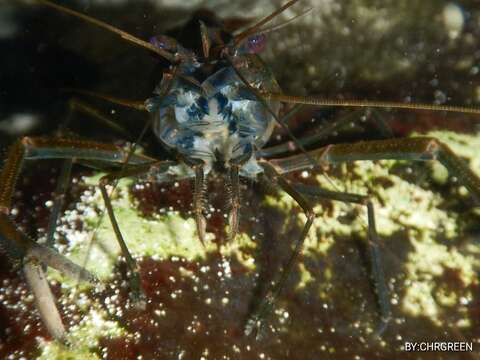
xmin=2 ymin=132 xmax=472 ymax=359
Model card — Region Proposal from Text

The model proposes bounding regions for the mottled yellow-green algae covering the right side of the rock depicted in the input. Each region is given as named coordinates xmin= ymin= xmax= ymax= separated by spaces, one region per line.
xmin=269 ymin=131 xmax=480 ymax=327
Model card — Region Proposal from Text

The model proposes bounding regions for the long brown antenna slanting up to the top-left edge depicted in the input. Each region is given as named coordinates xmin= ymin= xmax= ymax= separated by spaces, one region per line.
xmin=35 ymin=0 xmax=178 ymax=63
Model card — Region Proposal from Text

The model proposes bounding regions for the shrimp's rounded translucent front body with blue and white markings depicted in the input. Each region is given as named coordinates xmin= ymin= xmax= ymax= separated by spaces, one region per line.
xmin=147 ymin=64 xmax=274 ymax=177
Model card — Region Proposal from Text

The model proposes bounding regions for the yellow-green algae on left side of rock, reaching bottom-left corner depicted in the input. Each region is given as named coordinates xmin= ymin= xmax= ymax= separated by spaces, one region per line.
xmin=40 ymin=174 xmax=256 ymax=359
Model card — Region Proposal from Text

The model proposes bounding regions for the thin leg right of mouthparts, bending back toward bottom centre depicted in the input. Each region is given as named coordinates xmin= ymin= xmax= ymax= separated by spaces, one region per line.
xmin=245 ymin=162 xmax=315 ymax=339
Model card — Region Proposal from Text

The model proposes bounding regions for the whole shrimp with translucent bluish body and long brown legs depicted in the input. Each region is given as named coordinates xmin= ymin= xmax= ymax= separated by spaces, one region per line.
xmin=0 ymin=0 xmax=480 ymax=356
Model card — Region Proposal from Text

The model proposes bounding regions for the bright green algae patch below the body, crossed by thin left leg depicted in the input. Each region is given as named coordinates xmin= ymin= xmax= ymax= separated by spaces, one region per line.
xmin=50 ymin=174 xmax=214 ymax=280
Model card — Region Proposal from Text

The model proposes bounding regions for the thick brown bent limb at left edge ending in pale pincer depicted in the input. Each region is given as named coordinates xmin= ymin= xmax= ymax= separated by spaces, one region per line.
xmin=0 ymin=137 xmax=153 ymax=341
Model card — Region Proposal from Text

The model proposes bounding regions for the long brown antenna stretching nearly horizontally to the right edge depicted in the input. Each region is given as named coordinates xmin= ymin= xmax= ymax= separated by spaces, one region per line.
xmin=262 ymin=93 xmax=480 ymax=115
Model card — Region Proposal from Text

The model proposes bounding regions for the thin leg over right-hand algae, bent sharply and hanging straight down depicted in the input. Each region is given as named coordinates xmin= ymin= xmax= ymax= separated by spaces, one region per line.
xmin=294 ymin=185 xmax=391 ymax=335
